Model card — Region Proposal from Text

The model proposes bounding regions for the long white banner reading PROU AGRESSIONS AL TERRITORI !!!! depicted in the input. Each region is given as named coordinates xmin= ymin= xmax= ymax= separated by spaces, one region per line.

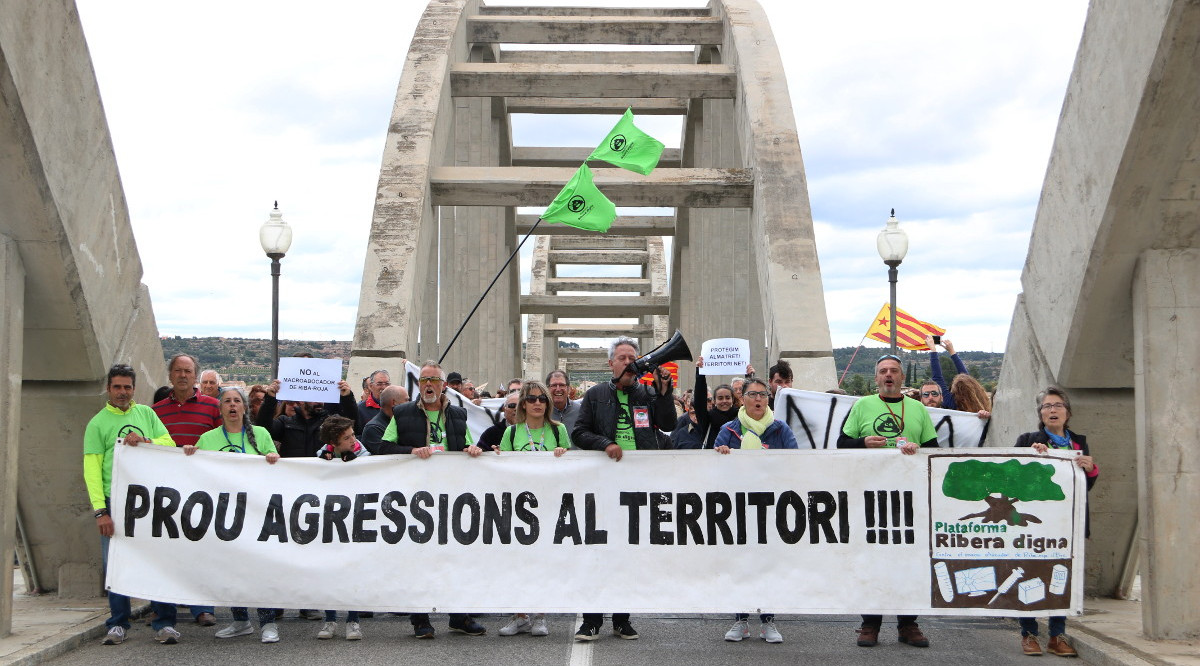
xmin=107 ymin=445 xmax=1086 ymax=616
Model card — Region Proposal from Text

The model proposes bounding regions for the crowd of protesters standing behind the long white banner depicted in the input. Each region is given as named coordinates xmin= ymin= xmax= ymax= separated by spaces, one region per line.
xmin=84 ymin=337 xmax=1099 ymax=656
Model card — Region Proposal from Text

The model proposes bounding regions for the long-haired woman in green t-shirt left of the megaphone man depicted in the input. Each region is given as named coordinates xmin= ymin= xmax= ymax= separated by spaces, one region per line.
xmin=496 ymin=379 xmax=571 ymax=636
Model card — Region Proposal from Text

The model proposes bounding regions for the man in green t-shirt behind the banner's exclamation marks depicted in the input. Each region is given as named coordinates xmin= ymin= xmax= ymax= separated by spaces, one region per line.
xmin=838 ymin=354 xmax=937 ymax=648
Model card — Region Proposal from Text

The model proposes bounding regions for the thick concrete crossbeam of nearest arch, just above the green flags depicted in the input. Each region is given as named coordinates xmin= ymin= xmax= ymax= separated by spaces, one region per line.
xmin=450 ymin=62 xmax=737 ymax=100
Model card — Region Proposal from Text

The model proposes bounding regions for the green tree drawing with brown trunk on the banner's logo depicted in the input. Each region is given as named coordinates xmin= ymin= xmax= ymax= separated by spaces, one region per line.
xmin=942 ymin=460 xmax=1066 ymax=527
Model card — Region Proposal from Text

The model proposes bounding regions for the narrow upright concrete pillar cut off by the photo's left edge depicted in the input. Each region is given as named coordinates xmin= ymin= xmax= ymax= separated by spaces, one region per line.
xmin=0 ymin=234 xmax=25 ymax=638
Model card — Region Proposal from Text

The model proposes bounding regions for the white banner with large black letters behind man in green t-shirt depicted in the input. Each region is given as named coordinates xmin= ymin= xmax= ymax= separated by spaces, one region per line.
xmin=772 ymin=388 xmax=988 ymax=449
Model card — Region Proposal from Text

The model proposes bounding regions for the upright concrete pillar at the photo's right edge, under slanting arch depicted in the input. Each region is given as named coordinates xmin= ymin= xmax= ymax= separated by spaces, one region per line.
xmin=1133 ymin=247 xmax=1200 ymax=640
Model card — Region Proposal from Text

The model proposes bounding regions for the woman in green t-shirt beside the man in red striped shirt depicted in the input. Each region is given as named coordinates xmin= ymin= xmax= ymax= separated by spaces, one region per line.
xmin=184 ymin=386 xmax=280 ymax=643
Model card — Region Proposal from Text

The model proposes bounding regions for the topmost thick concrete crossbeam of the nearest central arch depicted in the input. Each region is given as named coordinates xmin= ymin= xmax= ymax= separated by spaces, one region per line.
xmin=467 ymin=14 xmax=724 ymax=46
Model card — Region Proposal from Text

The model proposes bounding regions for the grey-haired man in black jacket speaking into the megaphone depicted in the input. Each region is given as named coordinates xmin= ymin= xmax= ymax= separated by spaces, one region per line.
xmin=571 ymin=337 xmax=676 ymax=641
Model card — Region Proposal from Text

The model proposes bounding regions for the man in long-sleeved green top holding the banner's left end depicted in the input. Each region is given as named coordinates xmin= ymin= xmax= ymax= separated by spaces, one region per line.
xmin=83 ymin=364 xmax=179 ymax=646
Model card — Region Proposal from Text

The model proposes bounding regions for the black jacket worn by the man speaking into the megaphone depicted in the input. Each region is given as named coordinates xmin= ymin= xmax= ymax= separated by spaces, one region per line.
xmin=571 ymin=382 xmax=676 ymax=451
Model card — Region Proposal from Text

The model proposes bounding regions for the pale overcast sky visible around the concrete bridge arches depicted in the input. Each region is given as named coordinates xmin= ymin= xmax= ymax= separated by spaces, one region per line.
xmin=77 ymin=0 xmax=1087 ymax=352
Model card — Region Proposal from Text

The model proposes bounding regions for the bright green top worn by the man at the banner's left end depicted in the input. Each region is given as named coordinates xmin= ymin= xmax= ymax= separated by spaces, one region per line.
xmin=83 ymin=402 xmax=175 ymax=509
